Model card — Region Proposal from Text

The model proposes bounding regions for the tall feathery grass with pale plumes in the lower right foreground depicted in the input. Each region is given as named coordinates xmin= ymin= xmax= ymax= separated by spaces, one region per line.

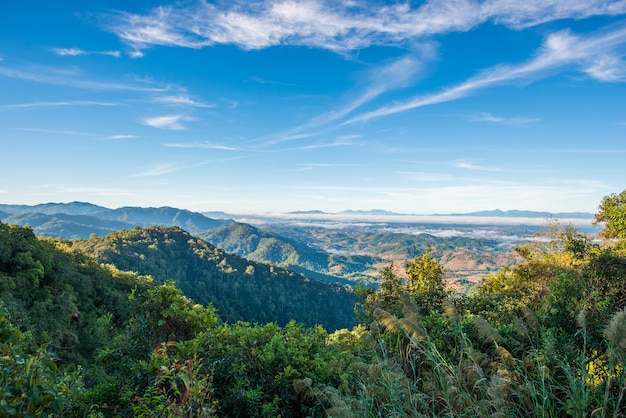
xmin=316 ymin=298 xmax=626 ymax=418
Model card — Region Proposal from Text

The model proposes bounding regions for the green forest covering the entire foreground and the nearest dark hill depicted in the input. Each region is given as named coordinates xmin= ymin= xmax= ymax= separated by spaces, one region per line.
xmin=0 ymin=190 xmax=626 ymax=417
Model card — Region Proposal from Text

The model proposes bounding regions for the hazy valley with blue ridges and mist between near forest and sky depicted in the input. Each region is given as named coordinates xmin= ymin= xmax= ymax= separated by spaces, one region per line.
xmin=0 ymin=202 xmax=596 ymax=290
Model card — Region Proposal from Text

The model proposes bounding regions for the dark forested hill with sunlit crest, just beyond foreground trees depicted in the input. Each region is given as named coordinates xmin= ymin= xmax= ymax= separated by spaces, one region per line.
xmin=72 ymin=226 xmax=357 ymax=330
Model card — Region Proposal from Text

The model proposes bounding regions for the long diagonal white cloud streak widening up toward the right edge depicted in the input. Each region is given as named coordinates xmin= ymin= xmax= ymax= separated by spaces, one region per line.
xmin=344 ymin=25 xmax=626 ymax=124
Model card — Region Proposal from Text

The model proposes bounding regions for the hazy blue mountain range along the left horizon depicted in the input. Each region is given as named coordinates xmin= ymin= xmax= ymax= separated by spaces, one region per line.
xmin=0 ymin=202 xmax=232 ymax=239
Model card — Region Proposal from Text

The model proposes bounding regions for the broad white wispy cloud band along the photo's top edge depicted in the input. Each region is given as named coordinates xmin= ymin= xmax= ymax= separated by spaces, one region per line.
xmin=110 ymin=0 xmax=626 ymax=52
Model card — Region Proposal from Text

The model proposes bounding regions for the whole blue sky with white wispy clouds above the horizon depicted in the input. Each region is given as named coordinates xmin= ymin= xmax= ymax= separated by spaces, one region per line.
xmin=0 ymin=0 xmax=626 ymax=214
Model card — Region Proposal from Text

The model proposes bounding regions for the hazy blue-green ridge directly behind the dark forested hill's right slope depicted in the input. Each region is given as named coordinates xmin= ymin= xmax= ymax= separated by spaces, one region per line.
xmin=200 ymin=222 xmax=380 ymax=283
